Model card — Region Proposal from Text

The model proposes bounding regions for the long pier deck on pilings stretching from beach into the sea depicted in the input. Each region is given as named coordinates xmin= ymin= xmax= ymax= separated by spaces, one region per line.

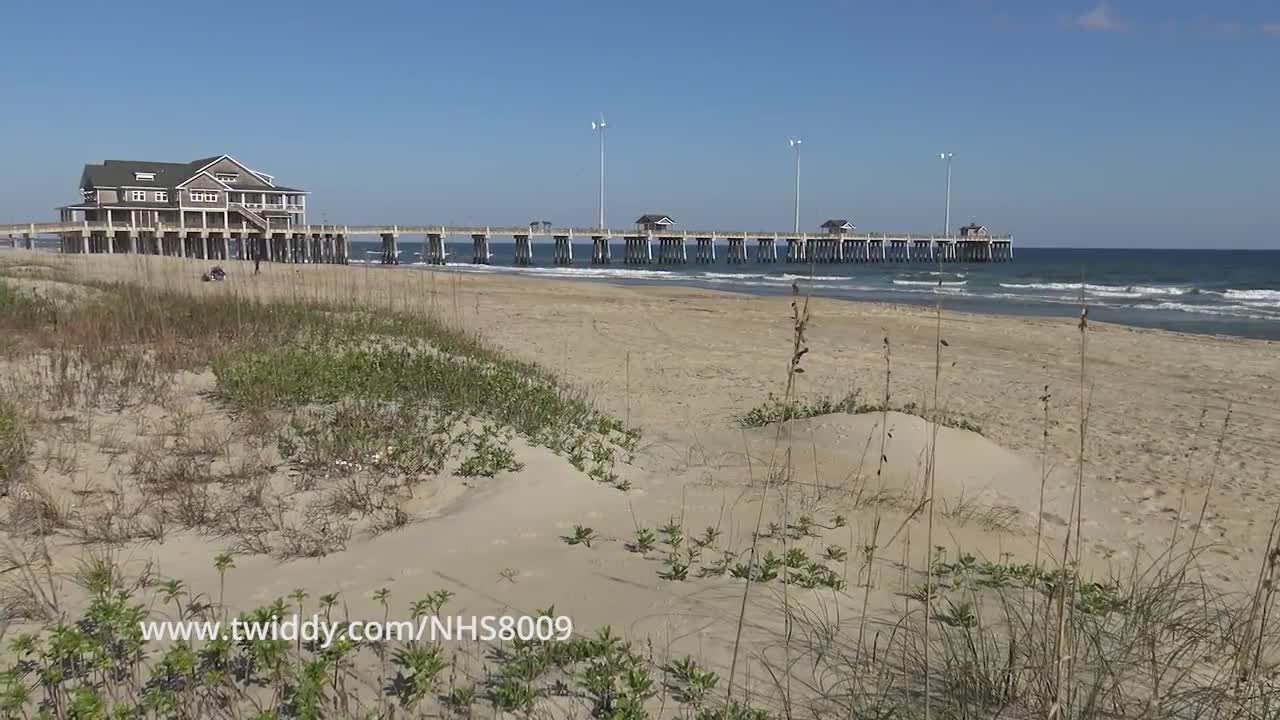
xmin=0 ymin=222 xmax=1014 ymax=265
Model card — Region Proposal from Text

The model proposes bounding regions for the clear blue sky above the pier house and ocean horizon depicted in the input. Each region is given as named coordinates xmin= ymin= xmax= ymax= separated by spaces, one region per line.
xmin=0 ymin=0 xmax=1280 ymax=249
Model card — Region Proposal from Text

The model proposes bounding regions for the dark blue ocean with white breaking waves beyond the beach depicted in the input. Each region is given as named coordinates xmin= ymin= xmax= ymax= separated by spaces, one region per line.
xmin=352 ymin=241 xmax=1280 ymax=340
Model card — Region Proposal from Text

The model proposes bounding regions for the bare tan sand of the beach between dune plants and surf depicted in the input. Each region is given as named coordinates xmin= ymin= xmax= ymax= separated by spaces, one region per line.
xmin=0 ymin=251 xmax=1280 ymax=712
